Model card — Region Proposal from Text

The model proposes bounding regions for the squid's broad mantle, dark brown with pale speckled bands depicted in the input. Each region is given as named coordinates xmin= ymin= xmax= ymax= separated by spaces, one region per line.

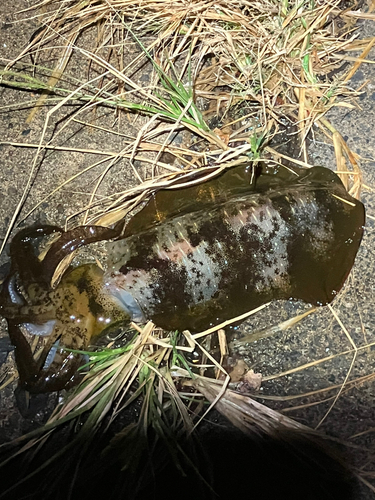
xmin=105 ymin=167 xmax=364 ymax=331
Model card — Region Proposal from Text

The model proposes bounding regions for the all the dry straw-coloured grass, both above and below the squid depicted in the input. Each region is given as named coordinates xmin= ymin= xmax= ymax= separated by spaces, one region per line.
xmin=0 ymin=0 xmax=375 ymax=496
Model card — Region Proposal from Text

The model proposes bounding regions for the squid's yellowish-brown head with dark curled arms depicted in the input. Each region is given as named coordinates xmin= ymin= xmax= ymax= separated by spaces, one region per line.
xmin=0 ymin=226 xmax=130 ymax=392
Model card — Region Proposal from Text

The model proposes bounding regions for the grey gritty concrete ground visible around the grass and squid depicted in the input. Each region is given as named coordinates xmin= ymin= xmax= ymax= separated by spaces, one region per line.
xmin=0 ymin=0 xmax=375 ymax=498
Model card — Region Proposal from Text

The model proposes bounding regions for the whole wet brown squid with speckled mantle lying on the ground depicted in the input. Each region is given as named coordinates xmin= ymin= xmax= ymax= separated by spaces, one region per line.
xmin=0 ymin=166 xmax=364 ymax=392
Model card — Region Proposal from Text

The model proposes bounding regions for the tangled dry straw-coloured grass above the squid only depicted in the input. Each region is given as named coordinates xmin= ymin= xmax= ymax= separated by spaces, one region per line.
xmin=2 ymin=0 xmax=368 ymax=247
